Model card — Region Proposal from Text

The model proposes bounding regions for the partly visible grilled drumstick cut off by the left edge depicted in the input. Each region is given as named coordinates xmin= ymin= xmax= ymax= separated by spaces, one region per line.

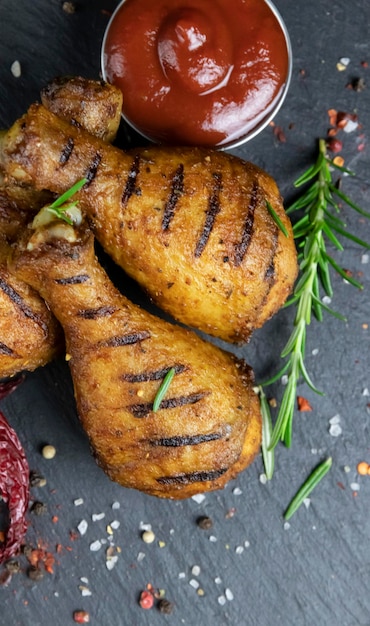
xmin=0 ymin=191 xmax=63 ymax=378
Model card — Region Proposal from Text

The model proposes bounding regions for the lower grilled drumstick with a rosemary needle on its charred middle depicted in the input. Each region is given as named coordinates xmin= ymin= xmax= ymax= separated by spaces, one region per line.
xmin=11 ymin=223 xmax=261 ymax=499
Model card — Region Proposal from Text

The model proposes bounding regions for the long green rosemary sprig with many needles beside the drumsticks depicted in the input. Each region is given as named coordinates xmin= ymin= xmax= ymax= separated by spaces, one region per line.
xmin=263 ymin=139 xmax=370 ymax=450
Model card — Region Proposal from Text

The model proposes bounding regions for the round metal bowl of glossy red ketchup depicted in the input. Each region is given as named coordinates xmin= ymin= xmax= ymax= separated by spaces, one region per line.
xmin=101 ymin=0 xmax=292 ymax=149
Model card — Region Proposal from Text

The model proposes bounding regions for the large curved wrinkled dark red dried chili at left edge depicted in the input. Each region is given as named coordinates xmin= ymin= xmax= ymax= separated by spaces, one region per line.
xmin=0 ymin=412 xmax=29 ymax=563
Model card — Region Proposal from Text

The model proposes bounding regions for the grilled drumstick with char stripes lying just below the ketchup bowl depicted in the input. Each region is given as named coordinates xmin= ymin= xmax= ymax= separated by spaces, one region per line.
xmin=2 ymin=105 xmax=298 ymax=342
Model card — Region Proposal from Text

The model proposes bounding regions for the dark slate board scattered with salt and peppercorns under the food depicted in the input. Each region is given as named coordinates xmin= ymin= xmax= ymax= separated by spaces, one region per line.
xmin=0 ymin=0 xmax=370 ymax=626
